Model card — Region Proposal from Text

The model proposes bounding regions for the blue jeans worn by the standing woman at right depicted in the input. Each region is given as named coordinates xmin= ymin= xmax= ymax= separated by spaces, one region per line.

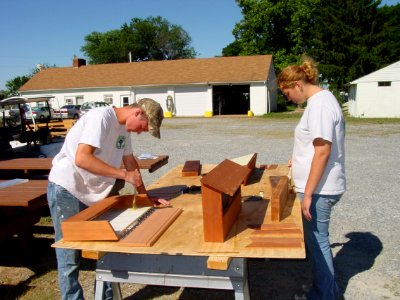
xmin=298 ymin=193 xmax=342 ymax=300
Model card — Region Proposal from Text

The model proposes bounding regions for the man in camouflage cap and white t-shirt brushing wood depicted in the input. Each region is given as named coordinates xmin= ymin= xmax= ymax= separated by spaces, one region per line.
xmin=47 ymin=98 xmax=169 ymax=299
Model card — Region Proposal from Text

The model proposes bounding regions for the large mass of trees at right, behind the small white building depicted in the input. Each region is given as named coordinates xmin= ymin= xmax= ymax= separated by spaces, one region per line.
xmin=223 ymin=0 xmax=400 ymax=91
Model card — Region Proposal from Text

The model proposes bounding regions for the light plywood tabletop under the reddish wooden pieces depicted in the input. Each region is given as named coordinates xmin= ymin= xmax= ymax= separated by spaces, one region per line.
xmin=54 ymin=165 xmax=305 ymax=258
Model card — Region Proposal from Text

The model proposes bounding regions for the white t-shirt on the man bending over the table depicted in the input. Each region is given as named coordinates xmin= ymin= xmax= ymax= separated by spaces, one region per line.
xmin=49 ymin=106 xmax=132 ymax=206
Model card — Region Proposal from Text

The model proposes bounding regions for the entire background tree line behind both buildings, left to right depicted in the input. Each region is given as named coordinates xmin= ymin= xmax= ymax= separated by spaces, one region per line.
xmin=0 ymin=0 xmax=400 ymax=97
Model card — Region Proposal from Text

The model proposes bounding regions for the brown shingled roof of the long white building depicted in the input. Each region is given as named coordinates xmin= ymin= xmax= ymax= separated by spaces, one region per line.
xmin=20 ymin=55 xmax=272 ymax=91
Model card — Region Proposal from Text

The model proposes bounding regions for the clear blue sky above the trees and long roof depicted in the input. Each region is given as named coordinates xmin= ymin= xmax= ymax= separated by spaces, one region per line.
xmin=0 ymin=0 xmax=400 ymax=90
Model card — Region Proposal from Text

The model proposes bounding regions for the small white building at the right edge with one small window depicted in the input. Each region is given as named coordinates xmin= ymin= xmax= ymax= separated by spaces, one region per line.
xmin=348 ymin=61 xmax=400 ymax=118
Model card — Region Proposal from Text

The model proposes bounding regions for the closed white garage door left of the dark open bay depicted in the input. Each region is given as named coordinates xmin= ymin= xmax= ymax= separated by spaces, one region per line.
xmin=175 ymin=87 xmax=207 ymax=116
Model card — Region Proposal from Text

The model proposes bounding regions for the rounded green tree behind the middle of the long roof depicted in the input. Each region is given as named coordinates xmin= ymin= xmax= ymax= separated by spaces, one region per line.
xmin=81 ymin=17 xmax=196 ymax=64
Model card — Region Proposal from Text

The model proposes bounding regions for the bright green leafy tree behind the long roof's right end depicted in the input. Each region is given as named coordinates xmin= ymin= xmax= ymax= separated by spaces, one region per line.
xmin=222 ymin=0 xmax=319 ymax=68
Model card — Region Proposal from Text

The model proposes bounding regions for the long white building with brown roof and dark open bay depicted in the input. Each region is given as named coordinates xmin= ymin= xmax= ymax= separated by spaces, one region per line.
xmin=19 ymin=55 xmax=277 ymax=116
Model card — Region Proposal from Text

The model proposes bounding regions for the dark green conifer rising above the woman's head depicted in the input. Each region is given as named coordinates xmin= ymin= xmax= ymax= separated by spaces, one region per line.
xmin=309 ymin=0 xmax=379 ymax=90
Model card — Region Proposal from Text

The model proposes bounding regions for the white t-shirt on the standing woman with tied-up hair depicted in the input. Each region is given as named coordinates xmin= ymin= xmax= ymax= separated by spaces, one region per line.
xmin=292 ymin=90 xmax=346 ymax=195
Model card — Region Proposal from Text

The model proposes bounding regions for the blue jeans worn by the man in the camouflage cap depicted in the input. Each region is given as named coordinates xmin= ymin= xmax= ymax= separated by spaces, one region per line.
xmin=47 ymin=181 xmax=112 ymax=300
